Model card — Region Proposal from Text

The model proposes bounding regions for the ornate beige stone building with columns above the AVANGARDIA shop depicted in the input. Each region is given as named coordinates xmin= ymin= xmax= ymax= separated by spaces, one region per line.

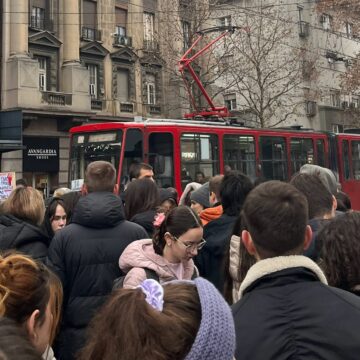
xmin=1 ymin=0 xmax=197 ymax=195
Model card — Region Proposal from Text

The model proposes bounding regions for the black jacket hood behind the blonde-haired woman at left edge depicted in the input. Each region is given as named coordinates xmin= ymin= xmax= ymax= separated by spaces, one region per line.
xmin=0 ymin=215 xmax=49 ymax=249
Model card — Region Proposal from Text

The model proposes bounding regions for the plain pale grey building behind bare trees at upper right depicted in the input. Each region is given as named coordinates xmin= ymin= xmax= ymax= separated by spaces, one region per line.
xmin=212 ymin=0 xmax=360 ymax=132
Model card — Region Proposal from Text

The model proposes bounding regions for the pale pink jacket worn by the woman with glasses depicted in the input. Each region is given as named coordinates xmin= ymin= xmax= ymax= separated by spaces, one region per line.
xmin=119 ymin=239 xmax=194 ymax=279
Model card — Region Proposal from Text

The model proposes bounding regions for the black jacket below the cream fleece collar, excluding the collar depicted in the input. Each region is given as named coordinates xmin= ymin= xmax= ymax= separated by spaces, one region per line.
xmin=232 ymin=267 xmax=360 ymax=360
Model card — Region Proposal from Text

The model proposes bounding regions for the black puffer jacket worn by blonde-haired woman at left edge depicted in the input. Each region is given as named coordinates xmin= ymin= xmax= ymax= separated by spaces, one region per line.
xmin=0 ymin=215 xmax=49 ymax=261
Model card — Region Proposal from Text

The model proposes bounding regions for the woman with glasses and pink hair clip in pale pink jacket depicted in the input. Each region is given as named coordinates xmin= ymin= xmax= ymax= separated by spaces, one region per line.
xmin=119 ymin=206 xmax=202 ymax=288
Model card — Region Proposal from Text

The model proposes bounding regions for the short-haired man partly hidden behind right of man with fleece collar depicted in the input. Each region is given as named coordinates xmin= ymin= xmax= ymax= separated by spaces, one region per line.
xmin=290 ymin=173 xmax=337 ymax=261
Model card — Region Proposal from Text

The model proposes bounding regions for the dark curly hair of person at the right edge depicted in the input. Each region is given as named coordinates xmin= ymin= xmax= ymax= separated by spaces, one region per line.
xmin=316 ymin=212 xmax=360 ymax=291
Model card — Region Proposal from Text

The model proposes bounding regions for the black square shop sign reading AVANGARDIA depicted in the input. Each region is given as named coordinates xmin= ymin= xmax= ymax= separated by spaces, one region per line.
xmin=23 ymin=137 xmax=59 ymax=172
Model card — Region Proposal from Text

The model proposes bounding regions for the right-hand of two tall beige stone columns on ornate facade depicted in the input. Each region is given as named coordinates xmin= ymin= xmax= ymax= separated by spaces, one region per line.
xmin=63 ymin=0 xmax=80 ymax=64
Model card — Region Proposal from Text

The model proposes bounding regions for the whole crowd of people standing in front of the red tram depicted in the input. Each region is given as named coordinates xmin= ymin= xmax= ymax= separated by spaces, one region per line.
xmin=0 ymin=161 xmax=360 ymax=360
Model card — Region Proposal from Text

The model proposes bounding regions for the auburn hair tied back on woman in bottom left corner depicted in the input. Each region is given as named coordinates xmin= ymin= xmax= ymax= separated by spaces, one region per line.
xmin=0 ymin=253 xmax=62 ymax=341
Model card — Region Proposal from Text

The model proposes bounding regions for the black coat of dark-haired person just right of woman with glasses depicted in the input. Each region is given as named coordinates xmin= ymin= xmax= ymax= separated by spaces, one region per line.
xmin=194 ymin=214 xmax=237 ymax=293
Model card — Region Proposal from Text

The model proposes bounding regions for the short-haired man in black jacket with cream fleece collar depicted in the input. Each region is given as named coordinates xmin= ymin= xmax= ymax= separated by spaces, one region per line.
xmin=232 ymin=181 xmax=360 ymax=360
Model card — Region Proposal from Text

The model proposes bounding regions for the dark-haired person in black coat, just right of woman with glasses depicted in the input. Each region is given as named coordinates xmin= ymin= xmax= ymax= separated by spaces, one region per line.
xmin=194 ymin=171 xmax=253 ymax=293
